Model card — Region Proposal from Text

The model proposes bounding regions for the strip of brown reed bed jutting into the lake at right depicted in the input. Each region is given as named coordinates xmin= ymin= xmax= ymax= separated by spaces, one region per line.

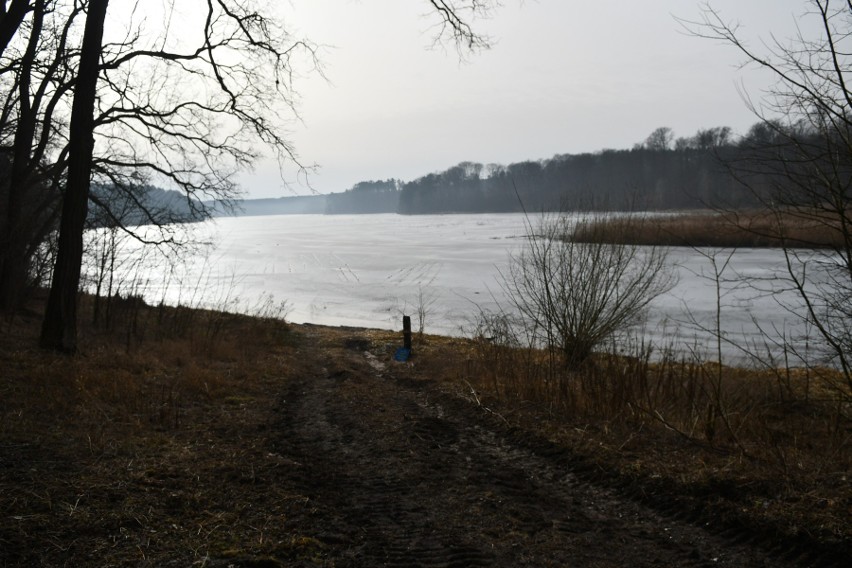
xmin=573 ymin=211 xmax=845 ymax=248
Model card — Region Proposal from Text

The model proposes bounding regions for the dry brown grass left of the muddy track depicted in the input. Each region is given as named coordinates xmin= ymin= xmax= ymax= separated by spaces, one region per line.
xmin=0 ymin=300 xmax=300 ymax=566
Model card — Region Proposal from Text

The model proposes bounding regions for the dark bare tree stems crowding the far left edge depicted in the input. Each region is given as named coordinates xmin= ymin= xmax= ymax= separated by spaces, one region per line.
xmin=0 ymin=0 xmax=82 ymax=310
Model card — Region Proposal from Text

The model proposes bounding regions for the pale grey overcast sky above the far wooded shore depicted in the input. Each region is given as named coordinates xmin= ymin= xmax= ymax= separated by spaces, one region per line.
xmin=215 ymin=0 xmax=806 ymax=197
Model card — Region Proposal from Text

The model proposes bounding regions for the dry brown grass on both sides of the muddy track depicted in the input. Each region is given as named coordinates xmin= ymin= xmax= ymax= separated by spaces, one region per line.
xmin=0 ymin=296 xmax=852 ymax=565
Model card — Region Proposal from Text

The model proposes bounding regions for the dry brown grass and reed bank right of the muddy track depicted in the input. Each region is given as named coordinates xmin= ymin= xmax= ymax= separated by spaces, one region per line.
xmin=440 ymin=332 xmax=852 ymax=542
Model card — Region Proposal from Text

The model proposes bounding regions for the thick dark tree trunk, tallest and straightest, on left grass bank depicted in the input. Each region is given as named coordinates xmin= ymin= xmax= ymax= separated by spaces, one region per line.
xmin=41 ymin=0 xmax=109 ymax=353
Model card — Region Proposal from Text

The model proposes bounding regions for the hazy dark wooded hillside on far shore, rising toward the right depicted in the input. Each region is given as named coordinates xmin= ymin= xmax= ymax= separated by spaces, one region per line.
xmin=231 ymin=123 xmax=778 ymax=215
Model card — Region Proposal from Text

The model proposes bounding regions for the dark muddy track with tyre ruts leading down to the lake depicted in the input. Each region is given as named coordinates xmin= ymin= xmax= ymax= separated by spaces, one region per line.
xmin=275 ymin=332 xmax=828 ymax=567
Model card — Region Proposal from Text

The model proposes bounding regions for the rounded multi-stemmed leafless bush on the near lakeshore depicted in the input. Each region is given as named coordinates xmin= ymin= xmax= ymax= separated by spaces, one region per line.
xmin=504 ymin=215 xmax=674 ymax=368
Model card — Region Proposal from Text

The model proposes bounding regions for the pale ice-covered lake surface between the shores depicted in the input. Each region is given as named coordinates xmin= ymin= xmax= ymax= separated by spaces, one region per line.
xmin=95 ymin=214 xmax=832 ymax=368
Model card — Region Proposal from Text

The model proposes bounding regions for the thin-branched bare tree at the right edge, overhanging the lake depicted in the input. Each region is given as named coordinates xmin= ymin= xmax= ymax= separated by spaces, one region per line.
xmin=683 ymin=0 xmax=852 ymax=389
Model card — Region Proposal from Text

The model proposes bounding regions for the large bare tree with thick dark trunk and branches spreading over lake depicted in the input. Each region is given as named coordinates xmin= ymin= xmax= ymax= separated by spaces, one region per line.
xmin=25 ymin=0 xmax=497 ymax=352
